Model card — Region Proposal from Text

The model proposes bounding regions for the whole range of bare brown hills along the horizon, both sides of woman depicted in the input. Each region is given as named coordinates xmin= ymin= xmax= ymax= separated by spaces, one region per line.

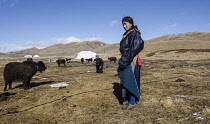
xmin=0 ymin=32 xmax=210 ymax=56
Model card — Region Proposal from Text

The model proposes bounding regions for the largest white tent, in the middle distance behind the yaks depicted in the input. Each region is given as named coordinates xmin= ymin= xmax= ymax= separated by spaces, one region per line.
xmin=75 ymin=51 xmax=96 ymax=59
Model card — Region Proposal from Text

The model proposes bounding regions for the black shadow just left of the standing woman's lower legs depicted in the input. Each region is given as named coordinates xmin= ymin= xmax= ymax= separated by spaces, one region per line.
xmin=112 ymin=82 xmax=123 ymax=104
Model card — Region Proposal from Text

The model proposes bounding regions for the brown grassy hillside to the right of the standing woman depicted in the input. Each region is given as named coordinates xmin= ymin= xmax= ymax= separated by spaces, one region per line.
xmin=141 ymin=32 xmax=210 ymax=60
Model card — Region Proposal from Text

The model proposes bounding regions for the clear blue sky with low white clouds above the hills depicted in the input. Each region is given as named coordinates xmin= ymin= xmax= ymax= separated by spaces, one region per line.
xmin=0 ymin=0 xmax=210 ymax=53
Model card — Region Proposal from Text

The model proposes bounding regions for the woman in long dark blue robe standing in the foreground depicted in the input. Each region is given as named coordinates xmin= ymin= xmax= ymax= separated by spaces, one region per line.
xmin=118 ymin=16 xmax=144 ymax=109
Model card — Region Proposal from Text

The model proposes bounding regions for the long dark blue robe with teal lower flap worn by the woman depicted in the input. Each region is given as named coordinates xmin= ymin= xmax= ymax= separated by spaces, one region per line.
xmin=118 ymin=27 xmax=144 ymax=101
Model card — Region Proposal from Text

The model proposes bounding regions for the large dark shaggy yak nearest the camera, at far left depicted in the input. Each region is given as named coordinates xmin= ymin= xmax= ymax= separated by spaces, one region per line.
xmin=4 ymin=61 xmax=47 ymax=91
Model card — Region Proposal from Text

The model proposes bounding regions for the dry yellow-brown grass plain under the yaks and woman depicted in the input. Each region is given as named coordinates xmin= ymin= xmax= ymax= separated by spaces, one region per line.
xmin=0 ymin=54 xmax=210 ymax=124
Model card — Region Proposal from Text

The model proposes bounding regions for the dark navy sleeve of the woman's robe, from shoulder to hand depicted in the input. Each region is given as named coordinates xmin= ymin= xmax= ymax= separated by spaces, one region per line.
xmin=119 ymin=31 xmax=144 ymax=67
